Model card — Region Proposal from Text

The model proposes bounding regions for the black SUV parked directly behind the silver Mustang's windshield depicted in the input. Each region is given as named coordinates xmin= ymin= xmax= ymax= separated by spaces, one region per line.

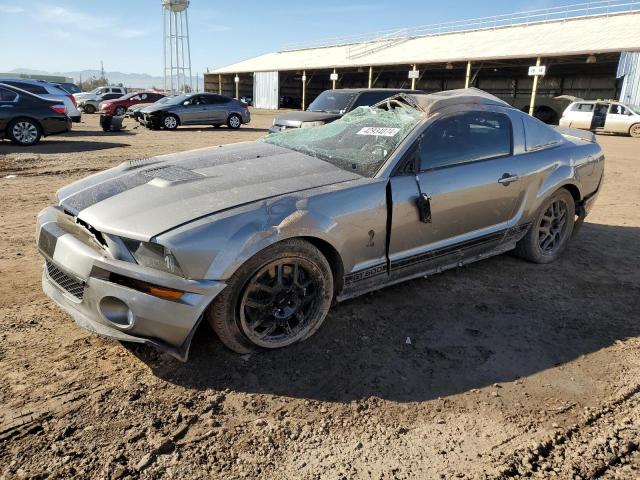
xmin=269 ymin=88 xmax=424 ymax=133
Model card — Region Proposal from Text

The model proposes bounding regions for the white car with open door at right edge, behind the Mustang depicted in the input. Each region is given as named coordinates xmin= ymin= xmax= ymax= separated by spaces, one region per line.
xmin=560 ymin=98 xmax=640 ymax=137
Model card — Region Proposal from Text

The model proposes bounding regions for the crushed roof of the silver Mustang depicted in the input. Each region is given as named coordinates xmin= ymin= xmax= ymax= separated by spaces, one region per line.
xmin=385 ymin=88 xmax=514 ymax=115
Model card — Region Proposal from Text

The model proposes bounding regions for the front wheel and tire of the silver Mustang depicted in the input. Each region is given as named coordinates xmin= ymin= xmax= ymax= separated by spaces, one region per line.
xmin=207 ymin=239 xmax=333 ymax=353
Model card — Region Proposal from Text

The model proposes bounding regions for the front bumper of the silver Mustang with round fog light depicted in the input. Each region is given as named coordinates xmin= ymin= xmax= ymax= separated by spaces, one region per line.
xmin=36 ymin=207 xmax=225 ymax=361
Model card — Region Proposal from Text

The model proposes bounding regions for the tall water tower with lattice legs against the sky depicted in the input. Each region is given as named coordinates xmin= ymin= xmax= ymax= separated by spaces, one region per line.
xmin=162 ymin=0 xmax=193 ymax=93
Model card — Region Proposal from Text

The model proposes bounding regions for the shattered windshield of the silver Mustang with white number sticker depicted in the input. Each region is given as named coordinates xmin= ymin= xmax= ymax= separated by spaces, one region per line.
xmin=260 ymin=107 xmax=424 ymax=177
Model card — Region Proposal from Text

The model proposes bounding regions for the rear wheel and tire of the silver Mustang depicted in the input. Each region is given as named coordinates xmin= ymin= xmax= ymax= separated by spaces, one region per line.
xmin=515 ymin=188 xmax=576 ymax=263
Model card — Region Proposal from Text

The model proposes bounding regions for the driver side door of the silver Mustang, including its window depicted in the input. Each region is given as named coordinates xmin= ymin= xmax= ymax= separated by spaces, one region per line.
xmin=389 ymin=110 xmax=522 ymax=280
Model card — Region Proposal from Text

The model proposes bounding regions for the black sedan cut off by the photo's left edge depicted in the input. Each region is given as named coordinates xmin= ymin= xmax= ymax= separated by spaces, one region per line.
xmin=0 ymin=83 xmax=71 ymax=146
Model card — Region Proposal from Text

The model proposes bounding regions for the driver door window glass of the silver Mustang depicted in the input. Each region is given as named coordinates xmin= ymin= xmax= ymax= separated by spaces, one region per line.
xmin=420 ymin=111 xmax=512 ymax=170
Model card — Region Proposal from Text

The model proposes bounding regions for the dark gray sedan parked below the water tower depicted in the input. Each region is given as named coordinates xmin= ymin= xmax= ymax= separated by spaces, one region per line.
xmin=140 ymin=93 xmax=251 ymax=130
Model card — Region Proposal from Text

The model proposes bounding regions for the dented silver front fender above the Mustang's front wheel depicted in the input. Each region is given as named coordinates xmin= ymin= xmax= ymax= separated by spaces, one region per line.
xmin=157 ymin=179 xmax=387 ymax=281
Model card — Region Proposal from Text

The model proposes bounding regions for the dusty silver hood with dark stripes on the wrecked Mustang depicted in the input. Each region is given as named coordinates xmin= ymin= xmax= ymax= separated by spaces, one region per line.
xmin=57 ymin=142 xmax=360 ymax=241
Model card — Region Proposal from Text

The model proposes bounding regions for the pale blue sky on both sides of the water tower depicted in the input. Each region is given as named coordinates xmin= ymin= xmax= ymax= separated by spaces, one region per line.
xmin=0 ymin=0 xmax=576 ymax=75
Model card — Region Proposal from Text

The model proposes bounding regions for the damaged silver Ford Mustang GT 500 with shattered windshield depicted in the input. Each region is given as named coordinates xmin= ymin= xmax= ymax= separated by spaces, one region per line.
xmin=37 ymin=89 xmax=604 ymax=359
